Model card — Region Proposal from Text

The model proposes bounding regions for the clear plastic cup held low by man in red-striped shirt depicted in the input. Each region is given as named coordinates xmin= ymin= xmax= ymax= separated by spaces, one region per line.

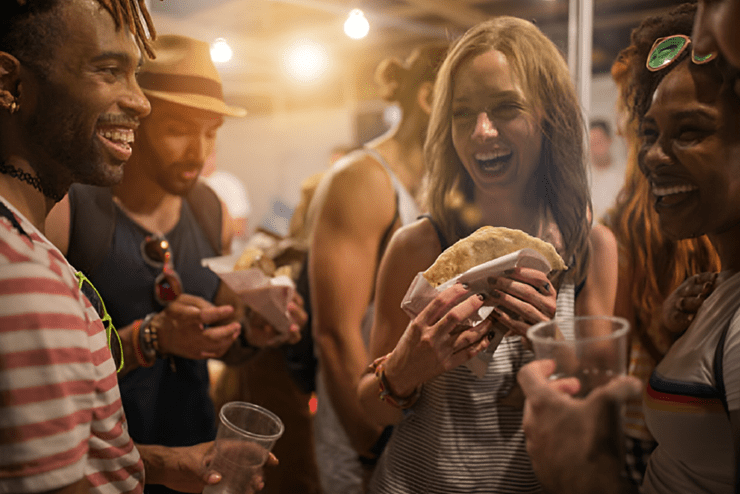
xmin=203 ymin=401 xmax=285 ymax=494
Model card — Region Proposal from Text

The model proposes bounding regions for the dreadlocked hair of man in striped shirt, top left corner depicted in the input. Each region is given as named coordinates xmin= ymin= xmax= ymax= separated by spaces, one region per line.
xmin=0 ymin=0 xmax=156 ymax=77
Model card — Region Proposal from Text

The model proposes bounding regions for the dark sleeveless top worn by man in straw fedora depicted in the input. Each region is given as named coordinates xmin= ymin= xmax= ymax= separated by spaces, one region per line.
xmin=68 ymin=185 xmax=220 ymax=492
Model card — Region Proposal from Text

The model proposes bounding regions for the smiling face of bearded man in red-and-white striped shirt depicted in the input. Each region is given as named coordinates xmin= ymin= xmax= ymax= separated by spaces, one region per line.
xmin=21 ymin=0 xmax=150 ymax=190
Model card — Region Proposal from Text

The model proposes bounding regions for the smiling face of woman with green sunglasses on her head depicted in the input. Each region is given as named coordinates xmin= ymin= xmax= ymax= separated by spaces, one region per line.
xmin=640 ymin=61 xmax=740 ymax=239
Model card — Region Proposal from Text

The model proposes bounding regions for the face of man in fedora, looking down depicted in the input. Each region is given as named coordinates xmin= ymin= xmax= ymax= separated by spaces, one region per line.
xmin=135 ymin=98 xmax=223 ymax=195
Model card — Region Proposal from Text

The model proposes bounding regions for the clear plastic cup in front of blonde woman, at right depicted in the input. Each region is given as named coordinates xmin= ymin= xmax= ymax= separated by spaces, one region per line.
xmin=527 ymin=316 xmax=629 ymax=397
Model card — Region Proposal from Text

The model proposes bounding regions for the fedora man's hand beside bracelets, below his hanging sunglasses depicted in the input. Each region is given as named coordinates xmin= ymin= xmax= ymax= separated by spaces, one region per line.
xmin=152 ymin=294 xmax=241 ymax=360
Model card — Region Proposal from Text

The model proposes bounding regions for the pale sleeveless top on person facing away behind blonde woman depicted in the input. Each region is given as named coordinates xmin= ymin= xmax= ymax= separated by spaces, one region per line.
xmin=314 ymin=148 xmax=419 ymax=494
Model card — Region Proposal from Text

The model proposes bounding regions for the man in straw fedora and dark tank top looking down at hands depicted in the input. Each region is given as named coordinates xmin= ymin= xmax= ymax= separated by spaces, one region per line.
xmin=47 ymin=35 xmax=305 ymax=492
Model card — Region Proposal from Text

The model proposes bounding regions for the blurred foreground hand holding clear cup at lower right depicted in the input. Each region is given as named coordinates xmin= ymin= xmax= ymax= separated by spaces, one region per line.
xmin=517 ymin=360 xmax=642 ymax=494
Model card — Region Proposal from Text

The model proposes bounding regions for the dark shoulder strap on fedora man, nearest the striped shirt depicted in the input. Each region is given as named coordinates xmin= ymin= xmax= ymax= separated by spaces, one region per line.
xmin=67 ymin=184 xmax=116 ymax=276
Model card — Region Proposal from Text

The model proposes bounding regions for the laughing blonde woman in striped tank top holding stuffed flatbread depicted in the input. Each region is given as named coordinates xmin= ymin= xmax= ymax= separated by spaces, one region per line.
xmin=358 ymin=16 xmax=617 ymax=494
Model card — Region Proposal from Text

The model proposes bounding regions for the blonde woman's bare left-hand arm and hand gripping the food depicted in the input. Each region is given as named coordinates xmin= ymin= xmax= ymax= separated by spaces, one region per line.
xmin=357 ymin=220 xmax=498 ymax=426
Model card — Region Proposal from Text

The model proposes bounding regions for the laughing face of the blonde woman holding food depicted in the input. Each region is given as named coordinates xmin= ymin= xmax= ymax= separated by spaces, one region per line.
xmin=452 ymin=50 xmax=542 ymax=204
